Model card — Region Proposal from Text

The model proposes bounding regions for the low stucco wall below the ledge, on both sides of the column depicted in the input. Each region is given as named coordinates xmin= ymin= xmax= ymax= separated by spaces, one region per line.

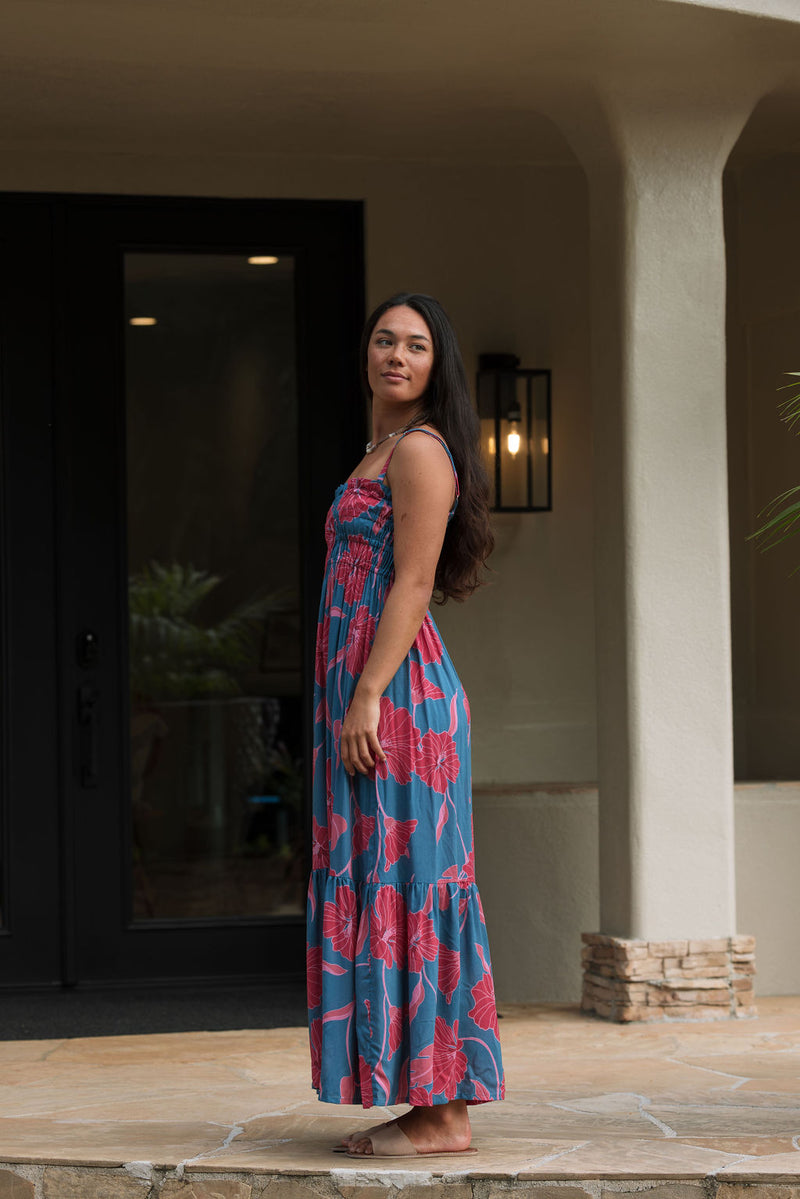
xmin=475 ymin=783 xmax=800 ymax=1002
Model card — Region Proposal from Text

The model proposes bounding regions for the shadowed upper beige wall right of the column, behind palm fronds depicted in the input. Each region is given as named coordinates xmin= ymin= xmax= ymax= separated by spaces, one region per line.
xmin=726 ymin=156 xmax=800 ymax=779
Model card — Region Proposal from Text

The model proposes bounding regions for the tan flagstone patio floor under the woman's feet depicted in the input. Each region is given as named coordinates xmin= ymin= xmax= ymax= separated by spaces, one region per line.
xmin=0 ymin=998 xmax=800 ymax=1199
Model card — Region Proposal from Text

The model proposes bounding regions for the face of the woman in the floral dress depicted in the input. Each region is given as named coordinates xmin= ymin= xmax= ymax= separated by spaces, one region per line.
xmin=367 ymin=305 xmax=433 ymax=405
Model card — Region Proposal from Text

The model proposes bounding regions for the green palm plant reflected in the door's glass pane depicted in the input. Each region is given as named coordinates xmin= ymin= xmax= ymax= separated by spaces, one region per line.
xmin=128 ymin=561 xmax=295 ymax=700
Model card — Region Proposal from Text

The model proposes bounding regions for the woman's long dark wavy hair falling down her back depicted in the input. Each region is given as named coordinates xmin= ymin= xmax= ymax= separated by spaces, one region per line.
xmin=361 ymin=291 xmax=494 ymax=603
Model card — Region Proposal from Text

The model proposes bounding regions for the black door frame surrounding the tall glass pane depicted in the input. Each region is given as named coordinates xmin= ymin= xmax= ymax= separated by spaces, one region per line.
xmin=0 ymin=193 xmax=365 ymax=984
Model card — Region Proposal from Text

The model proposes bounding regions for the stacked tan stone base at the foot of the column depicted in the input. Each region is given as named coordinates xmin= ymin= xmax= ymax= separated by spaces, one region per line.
xmin=581 ymin=933 xmax=756 ymax=1022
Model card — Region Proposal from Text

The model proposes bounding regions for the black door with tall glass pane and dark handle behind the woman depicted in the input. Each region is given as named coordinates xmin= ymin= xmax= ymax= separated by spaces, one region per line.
xmin=0 ymin=197 xmax=362 ymax=982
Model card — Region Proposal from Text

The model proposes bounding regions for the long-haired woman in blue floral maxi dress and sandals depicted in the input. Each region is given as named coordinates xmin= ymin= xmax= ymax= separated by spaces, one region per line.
xmin=307 ymin=294 xmax=504 ymax=1157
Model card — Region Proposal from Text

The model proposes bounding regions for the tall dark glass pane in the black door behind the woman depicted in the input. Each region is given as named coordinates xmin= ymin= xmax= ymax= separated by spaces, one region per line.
xmin=125 ymin=249 xmax=305 ymax=921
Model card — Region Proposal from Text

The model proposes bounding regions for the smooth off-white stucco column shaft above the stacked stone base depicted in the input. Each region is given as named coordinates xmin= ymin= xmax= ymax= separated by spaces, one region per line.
xmin=556 ymin=84 xmax=751 ymax=942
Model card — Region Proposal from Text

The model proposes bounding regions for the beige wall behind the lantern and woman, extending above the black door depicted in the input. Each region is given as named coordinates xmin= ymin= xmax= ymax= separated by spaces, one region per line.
xmin=0 ymin=151 xmax=596 ymax=783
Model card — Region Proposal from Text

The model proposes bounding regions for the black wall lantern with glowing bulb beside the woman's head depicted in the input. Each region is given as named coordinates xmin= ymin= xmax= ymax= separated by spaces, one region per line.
xmin=477 ymin=354 xmax=552 ymax=512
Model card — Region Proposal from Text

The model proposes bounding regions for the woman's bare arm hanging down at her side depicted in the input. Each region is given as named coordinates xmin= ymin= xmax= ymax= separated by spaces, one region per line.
xmin=339 ymin=433 xmax=455 ymax=775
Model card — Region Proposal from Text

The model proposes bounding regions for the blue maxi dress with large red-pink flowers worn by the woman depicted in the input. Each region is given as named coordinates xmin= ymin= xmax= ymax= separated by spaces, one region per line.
xmin=307 ymin=430 xmax=505 ymax=1108
